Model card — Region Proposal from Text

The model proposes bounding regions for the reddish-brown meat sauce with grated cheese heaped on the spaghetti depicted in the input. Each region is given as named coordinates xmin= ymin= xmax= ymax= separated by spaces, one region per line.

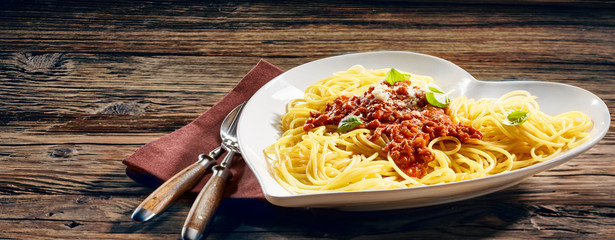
xmin=303 ymin=81 xmax=482 ymax=178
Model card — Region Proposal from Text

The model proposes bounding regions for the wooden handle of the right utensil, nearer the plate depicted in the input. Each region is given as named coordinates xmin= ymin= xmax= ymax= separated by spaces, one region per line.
xmin=182 ymin=166 xmax=231 ymax=239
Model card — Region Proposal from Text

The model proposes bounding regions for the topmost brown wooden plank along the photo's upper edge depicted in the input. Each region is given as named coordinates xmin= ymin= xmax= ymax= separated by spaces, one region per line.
xmin=0 ymin=2 xmax=614 ymax=59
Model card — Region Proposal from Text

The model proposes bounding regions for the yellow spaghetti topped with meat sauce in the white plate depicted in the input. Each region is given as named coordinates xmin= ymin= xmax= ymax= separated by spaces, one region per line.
xmin=264 ymin=65 xmax=592 ymax=194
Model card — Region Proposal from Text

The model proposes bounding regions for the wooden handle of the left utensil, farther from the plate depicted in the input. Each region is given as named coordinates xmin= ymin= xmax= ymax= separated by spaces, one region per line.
xmin=133 ymin=161 xmax=215 ymax=221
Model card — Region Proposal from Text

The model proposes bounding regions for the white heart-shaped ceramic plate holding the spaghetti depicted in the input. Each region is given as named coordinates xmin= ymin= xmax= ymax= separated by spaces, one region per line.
xmin=238 ymin=51 xmax=610 ymax=210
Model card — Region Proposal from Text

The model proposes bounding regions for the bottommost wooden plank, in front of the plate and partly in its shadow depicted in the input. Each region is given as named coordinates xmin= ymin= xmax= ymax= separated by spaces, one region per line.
xmin=0 ymin=193 xmax=615 ymax=239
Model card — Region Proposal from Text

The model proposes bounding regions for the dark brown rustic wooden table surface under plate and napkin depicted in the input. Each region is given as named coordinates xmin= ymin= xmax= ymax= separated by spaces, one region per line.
xmin=0 ymin=0 xmax=615 ymax=239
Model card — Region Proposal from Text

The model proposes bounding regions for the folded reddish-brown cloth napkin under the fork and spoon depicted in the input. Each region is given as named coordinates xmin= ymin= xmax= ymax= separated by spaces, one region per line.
xmin=123 ymin=59 xmax=283 ymax=198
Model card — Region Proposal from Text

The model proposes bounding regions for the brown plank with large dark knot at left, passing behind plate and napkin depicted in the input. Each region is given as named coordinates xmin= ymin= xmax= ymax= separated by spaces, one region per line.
xmin=0 ymin=54 xmax=615 ymax=116
